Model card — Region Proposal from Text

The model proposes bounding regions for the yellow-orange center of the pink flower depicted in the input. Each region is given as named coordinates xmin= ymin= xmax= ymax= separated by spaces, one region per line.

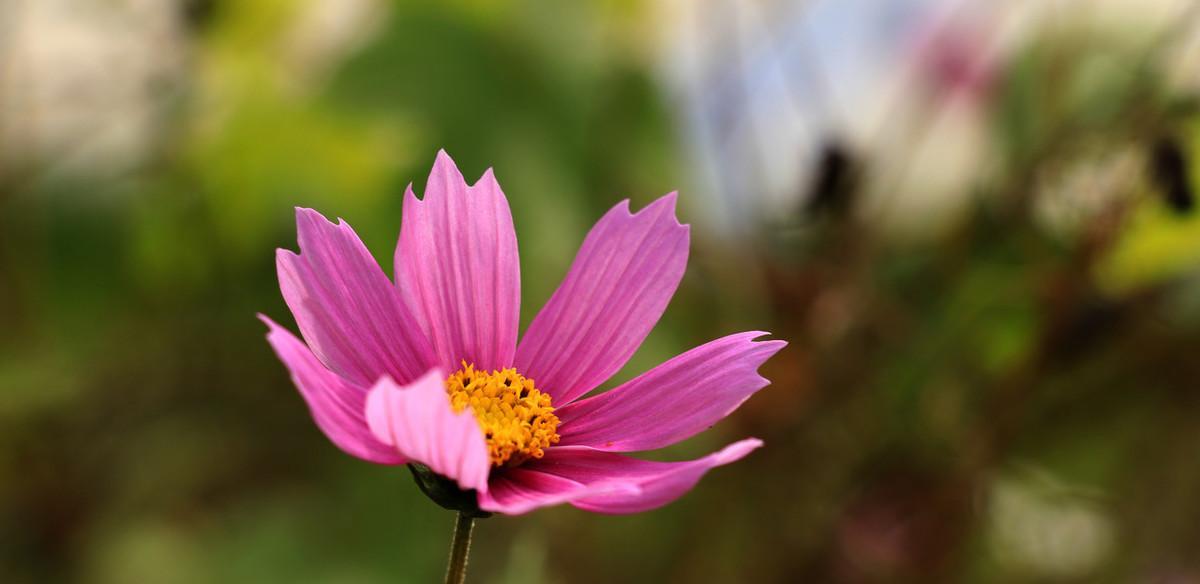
xmin=446 ymin=361 xmax=558 ymax=466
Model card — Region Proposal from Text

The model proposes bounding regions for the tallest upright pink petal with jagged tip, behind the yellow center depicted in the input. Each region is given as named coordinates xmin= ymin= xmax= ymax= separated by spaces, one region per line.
xmin=396 ymin=151 xmax=521 ymax=371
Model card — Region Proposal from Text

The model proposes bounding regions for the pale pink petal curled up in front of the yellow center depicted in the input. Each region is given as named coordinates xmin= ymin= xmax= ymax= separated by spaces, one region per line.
xmin=366 ymin=369 xmax=492 ymax=492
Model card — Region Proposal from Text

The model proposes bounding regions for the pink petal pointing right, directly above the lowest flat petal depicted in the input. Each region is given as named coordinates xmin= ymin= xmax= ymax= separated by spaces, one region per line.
xmin=554 ymin=332 xmax=787 ymax=452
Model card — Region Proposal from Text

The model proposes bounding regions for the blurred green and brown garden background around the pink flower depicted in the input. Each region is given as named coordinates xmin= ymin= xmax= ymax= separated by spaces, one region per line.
xmin=7 ymin=0 xmax=1200 ymax=583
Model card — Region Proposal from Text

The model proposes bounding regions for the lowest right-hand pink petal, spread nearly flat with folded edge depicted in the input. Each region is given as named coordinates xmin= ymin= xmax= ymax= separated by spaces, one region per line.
xmin=522 ymin=438 xmax=762 ymax=513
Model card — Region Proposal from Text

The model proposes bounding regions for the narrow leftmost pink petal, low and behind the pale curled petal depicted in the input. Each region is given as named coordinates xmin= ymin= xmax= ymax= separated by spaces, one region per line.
xmin=258 ymin=314 xmax=406 ymax=464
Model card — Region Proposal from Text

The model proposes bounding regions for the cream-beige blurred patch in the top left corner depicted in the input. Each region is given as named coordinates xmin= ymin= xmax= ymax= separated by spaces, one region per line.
xmin=0 ymin=0 xmax=184 ymax=179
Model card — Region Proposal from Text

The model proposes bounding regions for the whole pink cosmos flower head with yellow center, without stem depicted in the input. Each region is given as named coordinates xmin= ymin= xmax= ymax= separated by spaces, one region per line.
xmin=262 ymin=152 xmax=786 ymax=514
